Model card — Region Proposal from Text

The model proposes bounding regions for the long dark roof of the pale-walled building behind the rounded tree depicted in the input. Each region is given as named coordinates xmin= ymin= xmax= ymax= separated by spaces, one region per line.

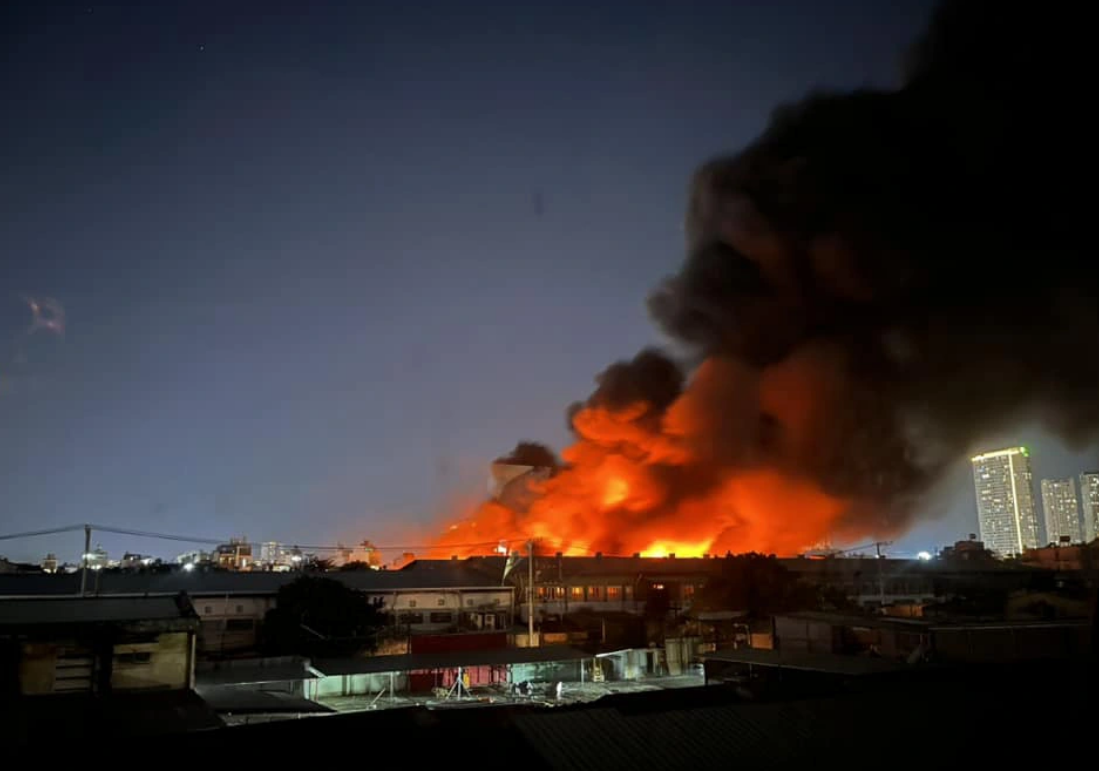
xmin=0 ymin=563 xmax=511 ymax=596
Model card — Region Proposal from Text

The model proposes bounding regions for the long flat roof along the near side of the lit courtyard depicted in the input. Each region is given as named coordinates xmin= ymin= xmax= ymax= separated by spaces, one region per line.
xmin=312 ymin=646 xmax=591 ymax=675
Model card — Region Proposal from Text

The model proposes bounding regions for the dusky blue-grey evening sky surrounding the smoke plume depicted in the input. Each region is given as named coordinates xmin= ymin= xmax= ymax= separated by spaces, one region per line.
xmin=0 ymin=0 xmax=1099 ymax=559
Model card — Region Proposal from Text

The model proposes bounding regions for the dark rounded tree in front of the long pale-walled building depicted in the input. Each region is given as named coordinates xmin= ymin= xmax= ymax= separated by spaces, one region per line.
xmin=264 ymin=576 xmax=385 ymax=656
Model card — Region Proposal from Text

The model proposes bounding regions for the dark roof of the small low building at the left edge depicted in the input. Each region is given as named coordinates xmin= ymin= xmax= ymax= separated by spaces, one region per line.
xmin=0 ymin=597 xmax=198 ymax=627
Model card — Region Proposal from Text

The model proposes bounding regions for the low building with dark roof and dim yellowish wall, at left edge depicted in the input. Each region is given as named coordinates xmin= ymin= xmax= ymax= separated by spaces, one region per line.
xmin=0 ymin=595 xmax=199 ymax=696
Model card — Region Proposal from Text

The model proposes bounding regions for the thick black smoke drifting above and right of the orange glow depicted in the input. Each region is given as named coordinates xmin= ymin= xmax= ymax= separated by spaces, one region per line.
xmin=650 ymin=1 xmax=1099 ymax=526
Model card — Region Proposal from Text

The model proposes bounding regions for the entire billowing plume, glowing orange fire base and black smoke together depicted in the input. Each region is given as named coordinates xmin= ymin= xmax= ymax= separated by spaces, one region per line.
xmin=433 ymin=1 xmax=1099 ymax=554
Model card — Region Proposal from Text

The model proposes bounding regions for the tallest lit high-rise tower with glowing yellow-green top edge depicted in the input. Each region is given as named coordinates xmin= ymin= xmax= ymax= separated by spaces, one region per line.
xmin=972 ymin=447 xmax=1040 ymax=557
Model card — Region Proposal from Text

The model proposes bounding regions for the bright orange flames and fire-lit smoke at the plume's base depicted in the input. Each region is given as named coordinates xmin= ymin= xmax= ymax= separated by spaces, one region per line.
xmin=428 ymin=361 xmax=862 ymax=557
